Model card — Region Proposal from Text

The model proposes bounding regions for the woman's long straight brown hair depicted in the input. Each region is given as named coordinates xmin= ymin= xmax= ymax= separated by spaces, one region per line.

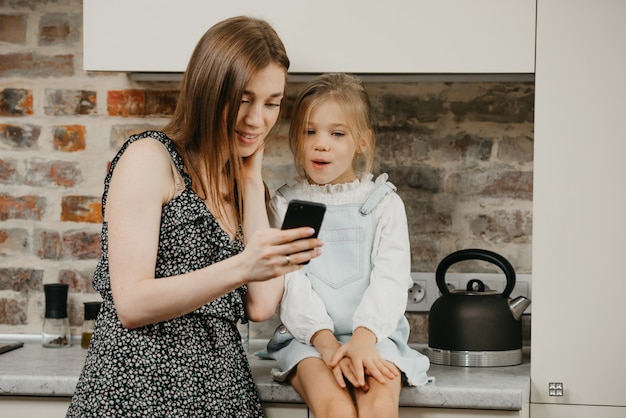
xmin=163 ymin=16 xmax=289 ymax=227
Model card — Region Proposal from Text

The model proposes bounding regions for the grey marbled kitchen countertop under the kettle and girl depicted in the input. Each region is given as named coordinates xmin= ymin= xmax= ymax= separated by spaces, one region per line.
xmin=0 ymin=335 xmax=530 ymax=410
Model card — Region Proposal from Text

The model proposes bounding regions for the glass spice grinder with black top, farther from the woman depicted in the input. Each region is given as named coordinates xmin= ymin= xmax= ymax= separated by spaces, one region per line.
xmin=41 ymin=283 xmax=71 ymax=348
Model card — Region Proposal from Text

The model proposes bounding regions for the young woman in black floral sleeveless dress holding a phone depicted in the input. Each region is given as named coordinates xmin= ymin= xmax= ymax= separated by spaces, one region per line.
xmin=67 ymin=17 xmax=321 ymax=418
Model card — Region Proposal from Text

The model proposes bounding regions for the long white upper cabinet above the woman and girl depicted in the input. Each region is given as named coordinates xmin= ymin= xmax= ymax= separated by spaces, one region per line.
xmin=83 ymin=0 xmax=536 ymax=74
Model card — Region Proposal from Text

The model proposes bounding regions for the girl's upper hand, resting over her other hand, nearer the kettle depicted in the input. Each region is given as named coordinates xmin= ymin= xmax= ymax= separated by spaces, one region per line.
xmin=329 ymin=327 xmax=400 ymax=390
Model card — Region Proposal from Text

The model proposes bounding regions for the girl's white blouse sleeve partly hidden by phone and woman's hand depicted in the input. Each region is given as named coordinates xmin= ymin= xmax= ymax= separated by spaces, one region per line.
xmin=268 ymin=191 xmax=335 ymax=344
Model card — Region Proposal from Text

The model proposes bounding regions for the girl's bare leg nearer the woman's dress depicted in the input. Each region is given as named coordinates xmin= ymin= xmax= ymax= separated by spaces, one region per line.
xmin=290 ymin=358 xmax=356 ymax=418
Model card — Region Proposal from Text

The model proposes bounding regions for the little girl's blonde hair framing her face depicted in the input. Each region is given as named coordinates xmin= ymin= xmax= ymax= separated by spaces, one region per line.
xmin=289 ymin=73 xmax=375 ymax=176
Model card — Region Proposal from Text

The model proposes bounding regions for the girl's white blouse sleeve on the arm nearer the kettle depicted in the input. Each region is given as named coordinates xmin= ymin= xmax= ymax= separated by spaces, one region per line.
xmin=353 ymin=193 xmax=413 ymax=341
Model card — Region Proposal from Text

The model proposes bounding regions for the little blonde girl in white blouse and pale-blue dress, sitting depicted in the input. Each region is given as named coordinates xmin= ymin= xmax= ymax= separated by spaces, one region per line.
xmin=267 ymin=73 xmax=429 ymax=418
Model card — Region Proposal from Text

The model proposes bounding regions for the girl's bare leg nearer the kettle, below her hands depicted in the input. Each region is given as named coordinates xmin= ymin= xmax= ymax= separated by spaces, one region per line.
xmin=354 ymin=375 xmax=402 ymax=418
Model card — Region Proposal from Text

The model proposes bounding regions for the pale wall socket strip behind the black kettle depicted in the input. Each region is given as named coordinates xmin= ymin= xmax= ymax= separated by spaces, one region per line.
xmin=406 ymin=272 xmax=532 ymax=314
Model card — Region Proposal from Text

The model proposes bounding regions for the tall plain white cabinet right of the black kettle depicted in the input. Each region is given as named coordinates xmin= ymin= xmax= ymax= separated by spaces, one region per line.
xmin=531 ymin=0 xmax=626 ymax=418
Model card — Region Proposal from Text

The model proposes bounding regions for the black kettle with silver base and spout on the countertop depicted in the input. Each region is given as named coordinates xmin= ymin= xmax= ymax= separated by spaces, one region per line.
xmin=427 ymin=249 xmax=530 ymax=366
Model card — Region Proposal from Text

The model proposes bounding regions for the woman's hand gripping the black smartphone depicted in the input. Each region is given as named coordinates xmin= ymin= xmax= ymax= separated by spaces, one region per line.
xmin=241 ymin=227 xmax=324 ymax=282
